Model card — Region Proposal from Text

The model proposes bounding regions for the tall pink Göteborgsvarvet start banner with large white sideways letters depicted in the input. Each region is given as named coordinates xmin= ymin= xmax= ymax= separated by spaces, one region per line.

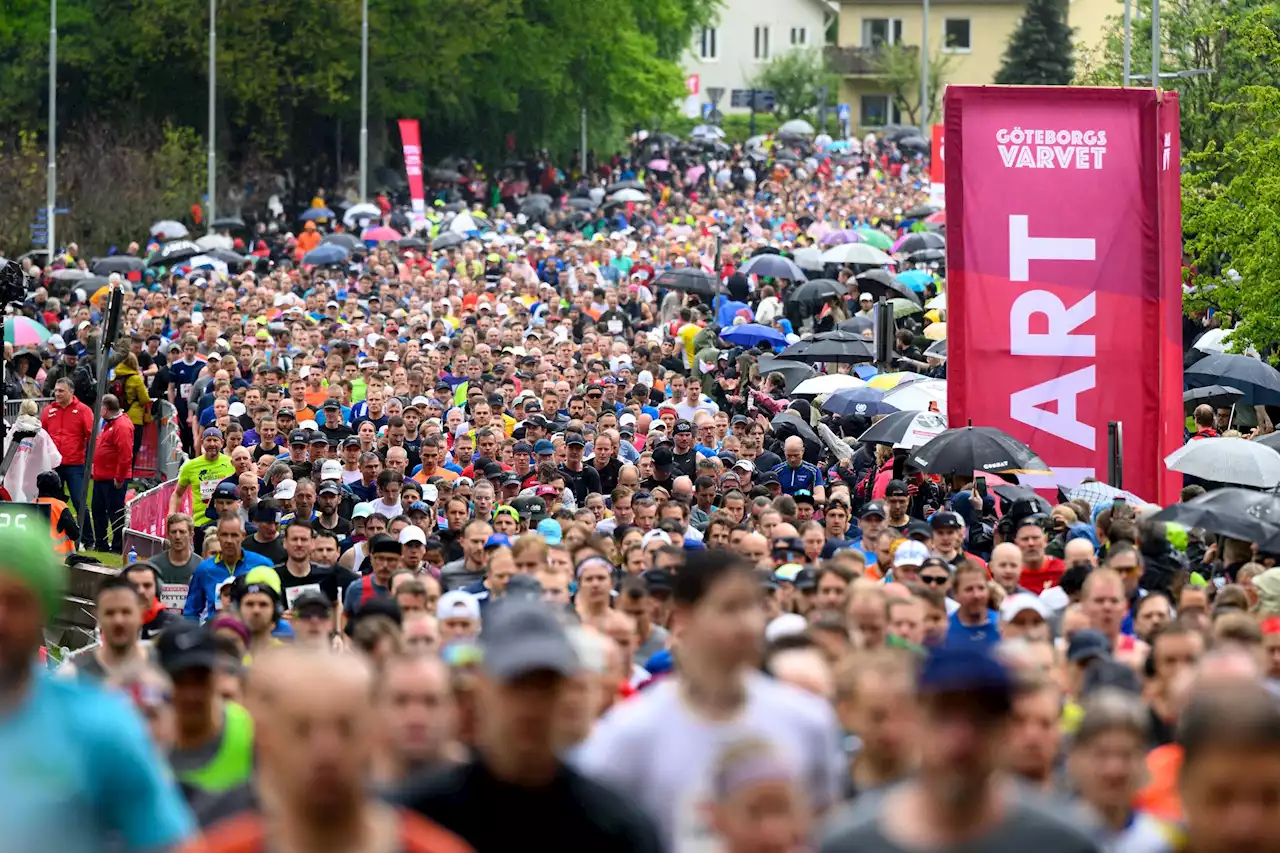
xmin=945 ymin=86 xmax=1183 ymax=503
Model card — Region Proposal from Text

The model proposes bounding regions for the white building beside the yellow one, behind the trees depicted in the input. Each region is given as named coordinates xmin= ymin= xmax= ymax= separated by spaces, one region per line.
xmin=684 ymin=0 xmax=837 ymax=115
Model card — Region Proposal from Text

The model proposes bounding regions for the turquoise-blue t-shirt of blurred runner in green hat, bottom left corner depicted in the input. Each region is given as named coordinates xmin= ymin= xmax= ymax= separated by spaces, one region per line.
xmin=0 ymin=671 xmax=196 ymax=853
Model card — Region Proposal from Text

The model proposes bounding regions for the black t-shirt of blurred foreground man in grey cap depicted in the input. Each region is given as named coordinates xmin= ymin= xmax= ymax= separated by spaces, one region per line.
xmin=396 ymin=761 xmax=662 ymax=853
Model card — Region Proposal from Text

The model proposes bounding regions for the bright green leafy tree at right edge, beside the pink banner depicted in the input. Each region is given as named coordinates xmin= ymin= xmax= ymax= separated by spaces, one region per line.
xmin=1183 ymin=18 xmax=1280 ymax=350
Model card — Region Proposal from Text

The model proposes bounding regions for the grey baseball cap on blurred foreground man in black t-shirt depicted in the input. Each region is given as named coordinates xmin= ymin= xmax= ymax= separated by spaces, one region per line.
xmin=480 ymin=598 xmax=579 ymax=681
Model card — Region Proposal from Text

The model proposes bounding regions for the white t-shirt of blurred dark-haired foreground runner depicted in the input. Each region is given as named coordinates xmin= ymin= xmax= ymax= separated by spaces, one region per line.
xmin=576 ymin=672 xmax=845 ymax=853
